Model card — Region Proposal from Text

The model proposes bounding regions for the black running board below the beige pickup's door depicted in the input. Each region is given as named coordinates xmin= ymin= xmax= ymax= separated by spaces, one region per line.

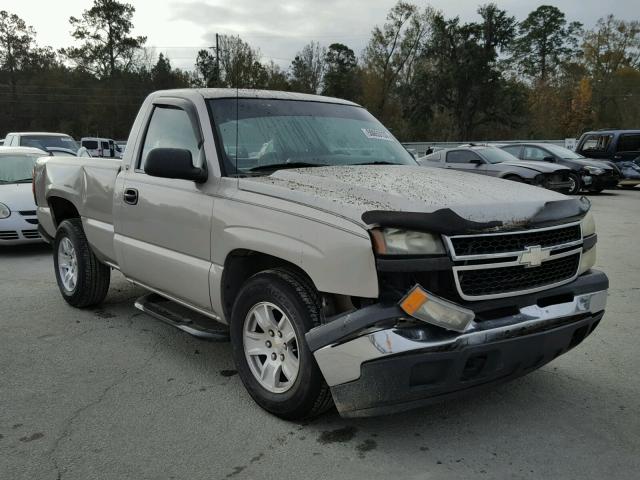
xmin=135 ymin=293 xmax=229 ymax=341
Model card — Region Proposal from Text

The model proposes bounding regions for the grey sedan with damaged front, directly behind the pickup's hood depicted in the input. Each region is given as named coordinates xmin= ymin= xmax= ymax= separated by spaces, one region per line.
xmin=418 ymin=145 xmax=572 ymax=193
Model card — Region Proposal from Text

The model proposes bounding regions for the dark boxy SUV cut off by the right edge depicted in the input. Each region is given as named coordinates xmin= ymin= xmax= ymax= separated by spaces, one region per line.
xmin=576 ymin=129 xmax=640 ymax=188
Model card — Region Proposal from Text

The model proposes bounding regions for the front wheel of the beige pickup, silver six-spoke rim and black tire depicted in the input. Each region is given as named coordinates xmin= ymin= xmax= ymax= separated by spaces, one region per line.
xmin=230 ymin=268 xmax=333 ymax=420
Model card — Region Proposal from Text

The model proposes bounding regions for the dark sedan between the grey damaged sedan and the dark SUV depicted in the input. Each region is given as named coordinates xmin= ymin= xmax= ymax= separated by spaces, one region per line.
xmin=500 ymin=143 xmax=620 ymax=195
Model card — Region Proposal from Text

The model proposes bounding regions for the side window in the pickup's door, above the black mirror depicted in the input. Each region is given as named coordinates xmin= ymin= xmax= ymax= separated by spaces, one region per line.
xmin=138 ymin=106 xmax=200 ymax=169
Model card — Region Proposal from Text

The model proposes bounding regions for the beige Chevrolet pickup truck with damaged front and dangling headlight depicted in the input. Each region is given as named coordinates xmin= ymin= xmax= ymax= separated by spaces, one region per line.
xmin=34 ymin=89 xmax=608 ymax=419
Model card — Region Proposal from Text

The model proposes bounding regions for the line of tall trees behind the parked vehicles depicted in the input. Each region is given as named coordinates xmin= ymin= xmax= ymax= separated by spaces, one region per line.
xmin=0 ymin=0 xmax=640 ymax=141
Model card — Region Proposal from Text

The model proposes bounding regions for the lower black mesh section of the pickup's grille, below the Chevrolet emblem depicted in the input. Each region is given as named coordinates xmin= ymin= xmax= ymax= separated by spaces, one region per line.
xmin=458 ymin=253 xmax=580 ymax=297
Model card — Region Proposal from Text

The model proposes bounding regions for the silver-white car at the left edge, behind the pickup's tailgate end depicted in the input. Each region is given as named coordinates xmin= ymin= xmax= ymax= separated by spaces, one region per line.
xmin=0 ymin=147 xmax=44 ymax=246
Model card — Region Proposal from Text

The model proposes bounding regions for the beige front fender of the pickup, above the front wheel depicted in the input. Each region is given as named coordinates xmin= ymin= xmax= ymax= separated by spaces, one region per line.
xmin=212 ymin=194 xmax=378 ymax=298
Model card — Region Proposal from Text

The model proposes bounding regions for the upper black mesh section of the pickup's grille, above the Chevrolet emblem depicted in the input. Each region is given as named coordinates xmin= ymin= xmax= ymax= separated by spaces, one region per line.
xmin=451 ymin=225 xmax=582 ymax=257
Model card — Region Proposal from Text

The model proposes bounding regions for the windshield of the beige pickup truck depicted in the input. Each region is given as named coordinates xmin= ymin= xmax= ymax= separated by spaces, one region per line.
xmin=210 ymin=98 xmax=416 ymax=175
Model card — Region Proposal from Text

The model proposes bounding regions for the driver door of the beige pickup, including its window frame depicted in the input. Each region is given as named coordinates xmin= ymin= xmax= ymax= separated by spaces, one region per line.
xmin=114 ymin=99 xmax=213 ymax=310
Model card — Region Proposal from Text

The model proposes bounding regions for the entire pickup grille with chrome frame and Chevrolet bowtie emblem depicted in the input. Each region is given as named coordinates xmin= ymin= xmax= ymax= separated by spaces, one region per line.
xmin=444 ymin=223 xmax=583 ymax=300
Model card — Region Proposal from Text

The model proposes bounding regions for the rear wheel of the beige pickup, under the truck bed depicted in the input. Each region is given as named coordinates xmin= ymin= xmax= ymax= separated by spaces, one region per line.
xmin=53 ymin=218 xmax=111 ymax=308
